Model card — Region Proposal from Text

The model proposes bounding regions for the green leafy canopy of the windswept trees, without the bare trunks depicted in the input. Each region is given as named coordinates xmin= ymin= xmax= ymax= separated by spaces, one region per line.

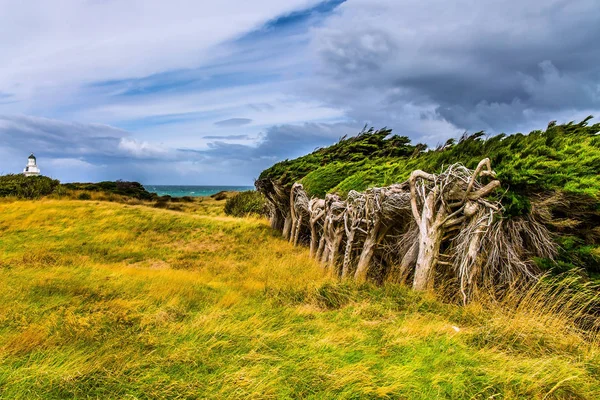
xmin=259 ymin=117 xmax=600 ymax=273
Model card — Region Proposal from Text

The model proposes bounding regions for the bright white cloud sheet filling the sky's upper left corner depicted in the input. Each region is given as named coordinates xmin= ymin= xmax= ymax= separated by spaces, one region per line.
xmin=0 ymin=0 xmax=317 ymax=100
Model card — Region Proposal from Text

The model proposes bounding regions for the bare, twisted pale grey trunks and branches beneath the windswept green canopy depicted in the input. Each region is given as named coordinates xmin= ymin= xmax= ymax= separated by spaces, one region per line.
xmin=258 ymin=158 xmax=555 ymax=302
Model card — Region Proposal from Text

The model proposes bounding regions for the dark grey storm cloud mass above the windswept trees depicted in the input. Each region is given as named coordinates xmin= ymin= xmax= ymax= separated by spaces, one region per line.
xmin=313 ymin=0 xmax=600 ymax=131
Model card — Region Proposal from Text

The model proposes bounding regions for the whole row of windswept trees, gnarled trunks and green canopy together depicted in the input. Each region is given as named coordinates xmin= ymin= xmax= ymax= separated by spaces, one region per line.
xmin=257 ymin=117 xmax=600 ymax=296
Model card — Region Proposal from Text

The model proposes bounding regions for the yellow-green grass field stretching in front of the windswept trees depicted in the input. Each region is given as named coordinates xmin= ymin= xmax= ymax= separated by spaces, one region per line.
xmin=0 ymin=200 xmax=600 ymax=399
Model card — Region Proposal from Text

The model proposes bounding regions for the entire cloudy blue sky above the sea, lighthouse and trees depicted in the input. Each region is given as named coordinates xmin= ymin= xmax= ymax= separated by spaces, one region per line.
xmin=0 ymin=0 xmax=600 ymax=185
